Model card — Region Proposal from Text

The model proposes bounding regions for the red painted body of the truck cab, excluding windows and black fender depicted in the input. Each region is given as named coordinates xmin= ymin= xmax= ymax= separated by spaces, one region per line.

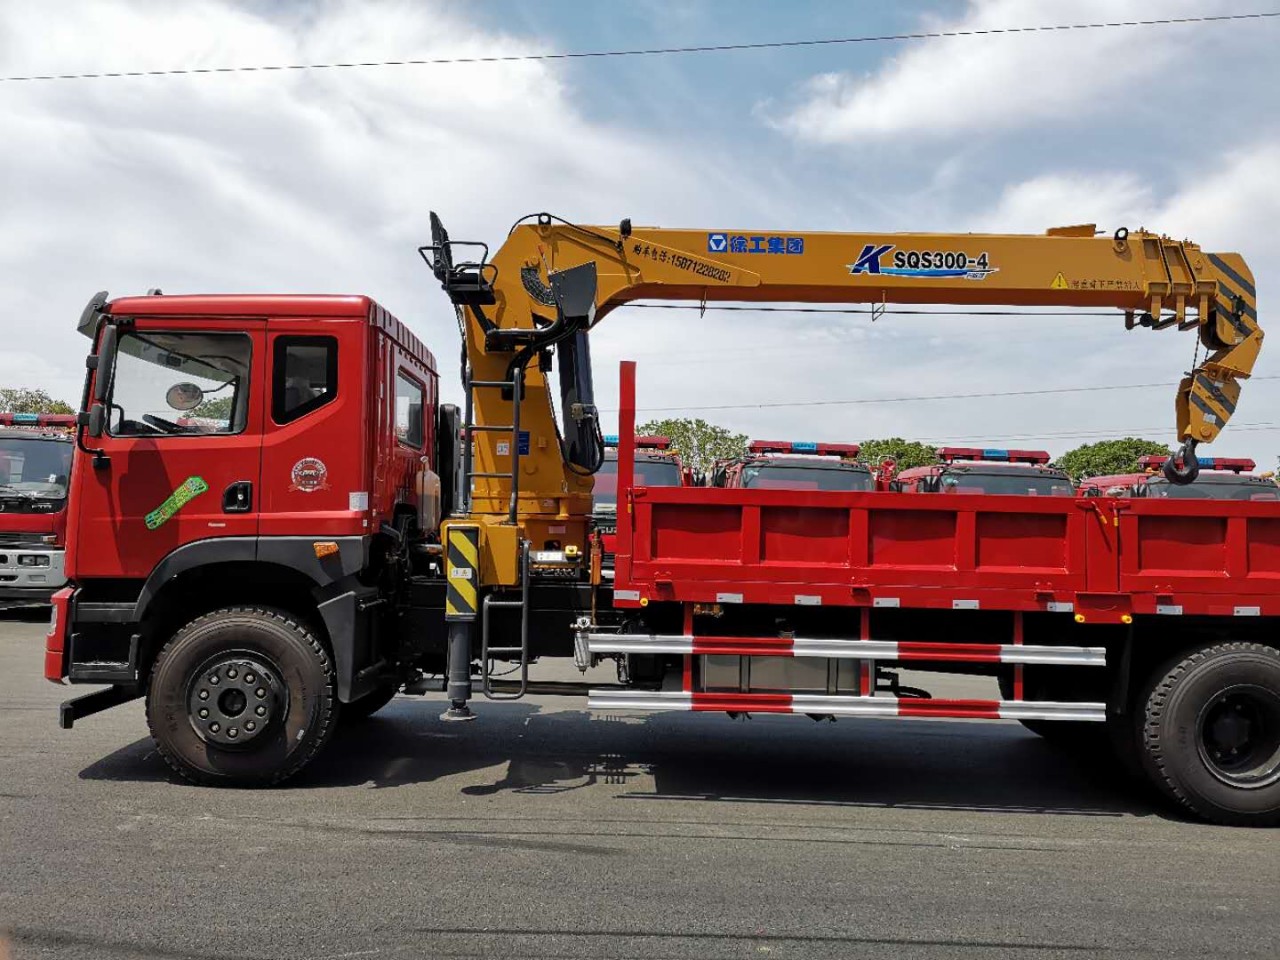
xmin=67 ymin=296 xmax=438 ymax=580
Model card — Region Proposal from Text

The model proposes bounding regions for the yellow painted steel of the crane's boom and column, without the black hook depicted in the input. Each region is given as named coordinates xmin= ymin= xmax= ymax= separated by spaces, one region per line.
xmin=448 ymin=221 xmax=1262 ymax=584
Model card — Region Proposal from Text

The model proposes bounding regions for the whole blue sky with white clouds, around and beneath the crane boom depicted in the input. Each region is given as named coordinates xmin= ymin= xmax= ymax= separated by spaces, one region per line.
xmin=0 ymin=0 xmax=1280 ymax=466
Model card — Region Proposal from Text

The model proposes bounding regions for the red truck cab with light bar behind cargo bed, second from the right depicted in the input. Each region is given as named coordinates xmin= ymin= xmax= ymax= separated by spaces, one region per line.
xmin=896 ymin=447 xmax=1075 ymax=497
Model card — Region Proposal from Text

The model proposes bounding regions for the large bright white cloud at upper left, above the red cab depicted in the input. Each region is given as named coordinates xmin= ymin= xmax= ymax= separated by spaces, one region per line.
xmin=0 ymin=0 xmax=760 ymax=409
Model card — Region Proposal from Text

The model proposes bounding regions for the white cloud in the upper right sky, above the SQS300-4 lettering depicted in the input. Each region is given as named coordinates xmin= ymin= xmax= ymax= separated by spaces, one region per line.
xmin=773 ymin=0 xmax=1233 ymax=143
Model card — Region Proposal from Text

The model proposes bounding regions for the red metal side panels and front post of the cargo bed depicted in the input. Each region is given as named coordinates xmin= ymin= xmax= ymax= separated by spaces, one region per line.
xmin=614 ymin=365 xmax=1280 ymax=619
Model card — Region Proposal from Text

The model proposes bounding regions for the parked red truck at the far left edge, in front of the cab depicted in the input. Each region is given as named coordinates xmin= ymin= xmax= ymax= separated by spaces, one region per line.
xmin=0 ymin=413 xmax=76 ymax=604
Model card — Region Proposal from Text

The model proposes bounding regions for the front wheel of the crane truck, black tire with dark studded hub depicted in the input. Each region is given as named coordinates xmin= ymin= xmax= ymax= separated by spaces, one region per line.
xmin=147 ymin=607 xmax=338 ymax=787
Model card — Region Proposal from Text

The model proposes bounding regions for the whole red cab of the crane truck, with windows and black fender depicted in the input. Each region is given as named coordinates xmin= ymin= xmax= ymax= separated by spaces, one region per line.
xmin=45 ymin=294 xmax=440 ymax=722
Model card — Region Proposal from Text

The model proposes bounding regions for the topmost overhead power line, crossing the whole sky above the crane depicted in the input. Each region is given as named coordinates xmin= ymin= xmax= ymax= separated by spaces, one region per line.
xmin=0 ymin=10 xmax=1280 ymax=83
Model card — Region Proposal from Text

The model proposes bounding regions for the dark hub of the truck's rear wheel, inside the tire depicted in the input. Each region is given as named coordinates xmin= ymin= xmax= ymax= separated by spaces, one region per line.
xmin=1198 ymin=685 xmax=1280 ymax=788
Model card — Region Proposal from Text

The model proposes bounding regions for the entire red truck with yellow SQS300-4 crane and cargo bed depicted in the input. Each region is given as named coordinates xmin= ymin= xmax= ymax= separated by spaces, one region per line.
xmin=45 ymin=214 xmax=1280 ymax=824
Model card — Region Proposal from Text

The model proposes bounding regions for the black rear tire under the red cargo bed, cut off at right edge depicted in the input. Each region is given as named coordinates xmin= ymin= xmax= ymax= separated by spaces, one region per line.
xmin=1142 ymin=643 xmax=1280 ymax=827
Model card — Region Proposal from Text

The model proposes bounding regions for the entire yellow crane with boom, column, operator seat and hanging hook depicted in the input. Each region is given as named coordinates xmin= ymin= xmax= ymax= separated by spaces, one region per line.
xmin=420 ymin=214 xmax=1262 ymax=582
